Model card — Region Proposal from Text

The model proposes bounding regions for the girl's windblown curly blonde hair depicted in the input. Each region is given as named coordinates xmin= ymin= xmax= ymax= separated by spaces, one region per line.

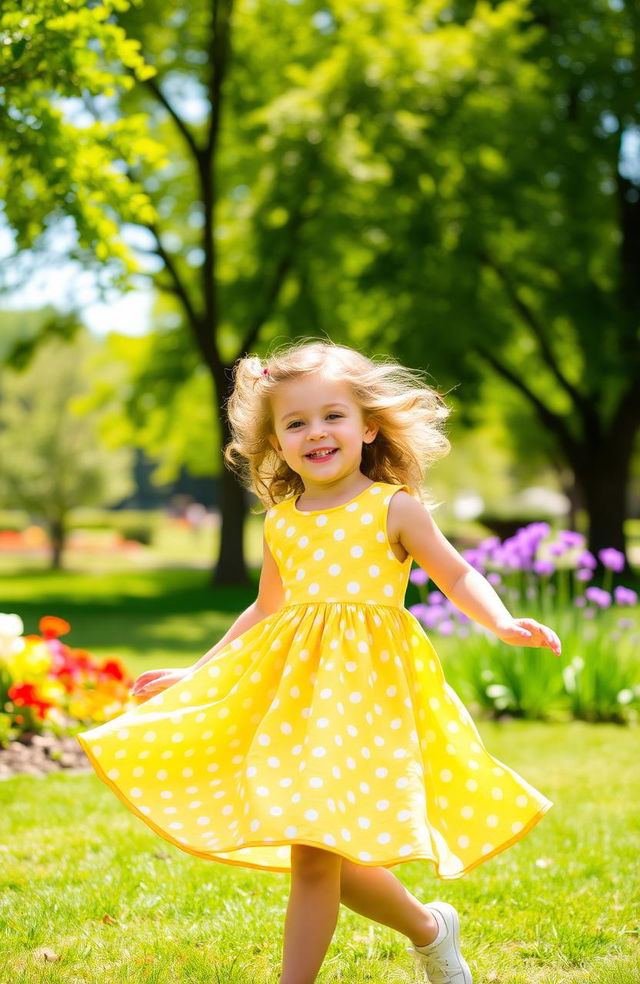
xmin=224 ymin=339 xmax=451 ymax=508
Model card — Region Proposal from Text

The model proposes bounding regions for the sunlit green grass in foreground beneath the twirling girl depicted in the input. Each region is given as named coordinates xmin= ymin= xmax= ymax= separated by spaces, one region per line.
xmin=0 ymin=721 xmax=640 ymax=984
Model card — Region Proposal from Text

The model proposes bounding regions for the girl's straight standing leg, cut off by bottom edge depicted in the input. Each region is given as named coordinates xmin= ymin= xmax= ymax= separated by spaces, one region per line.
xmin=280 ymin=844 xmax=343 ymax=984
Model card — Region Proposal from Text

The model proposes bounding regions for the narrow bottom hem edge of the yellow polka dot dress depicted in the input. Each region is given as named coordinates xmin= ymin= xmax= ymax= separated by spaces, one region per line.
xmin=76 ymin=735 xmax=553 ymax=881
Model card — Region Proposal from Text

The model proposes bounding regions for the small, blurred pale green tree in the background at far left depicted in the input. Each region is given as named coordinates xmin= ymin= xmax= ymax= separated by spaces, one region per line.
xmin=0 ymin=322 xmax=132 ymax=568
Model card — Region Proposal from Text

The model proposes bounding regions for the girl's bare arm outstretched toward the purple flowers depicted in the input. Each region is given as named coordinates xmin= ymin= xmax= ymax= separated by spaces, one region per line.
xmin=388 ymin=491 xmax=561 ymax=656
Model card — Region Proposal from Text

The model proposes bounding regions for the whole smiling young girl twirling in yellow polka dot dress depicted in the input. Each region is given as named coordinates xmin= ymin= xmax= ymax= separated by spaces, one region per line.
xmin=78 ymin=342 xmax=560 ymax=984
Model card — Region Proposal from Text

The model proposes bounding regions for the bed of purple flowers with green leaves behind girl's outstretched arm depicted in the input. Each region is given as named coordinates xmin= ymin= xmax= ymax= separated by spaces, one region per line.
xmin=409 ymin=523 xmax=640 ymax=724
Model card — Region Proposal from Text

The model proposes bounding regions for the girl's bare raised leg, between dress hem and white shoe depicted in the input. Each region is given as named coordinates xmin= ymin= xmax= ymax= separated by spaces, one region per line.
xmin=340 ymin=858 xmax=438 ymax=946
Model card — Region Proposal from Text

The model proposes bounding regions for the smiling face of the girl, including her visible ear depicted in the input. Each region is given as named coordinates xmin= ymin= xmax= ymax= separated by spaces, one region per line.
xmin=269 ymin=375 xmax=378 ymax=490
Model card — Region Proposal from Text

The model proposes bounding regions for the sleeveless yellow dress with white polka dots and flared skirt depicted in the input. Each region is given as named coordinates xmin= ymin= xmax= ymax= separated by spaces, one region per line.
xmin=78 ymin=482 xmax=552 ymax=879
